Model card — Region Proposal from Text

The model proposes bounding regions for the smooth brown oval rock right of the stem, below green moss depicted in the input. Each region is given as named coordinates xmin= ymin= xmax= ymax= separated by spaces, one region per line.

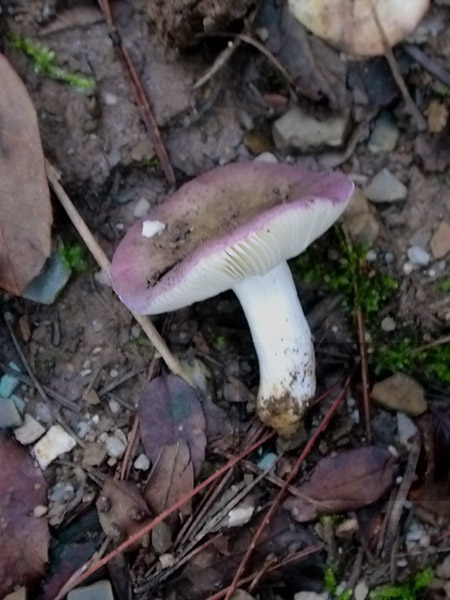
xmin=371 ymin=373 xmax=428 ymax=417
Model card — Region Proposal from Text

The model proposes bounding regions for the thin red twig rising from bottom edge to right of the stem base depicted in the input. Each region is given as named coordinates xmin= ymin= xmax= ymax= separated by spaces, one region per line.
xmin=225 ymin=378 xmax=350 ymax=600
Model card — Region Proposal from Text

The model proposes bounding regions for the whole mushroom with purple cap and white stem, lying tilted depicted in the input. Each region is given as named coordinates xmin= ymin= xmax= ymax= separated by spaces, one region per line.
xmin=111 ymin=162 xmax=353 ymax=438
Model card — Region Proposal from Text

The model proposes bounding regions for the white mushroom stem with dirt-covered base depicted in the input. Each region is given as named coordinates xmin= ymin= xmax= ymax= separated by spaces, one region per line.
xmin=233 ymin=261 xmax=316 ymax=436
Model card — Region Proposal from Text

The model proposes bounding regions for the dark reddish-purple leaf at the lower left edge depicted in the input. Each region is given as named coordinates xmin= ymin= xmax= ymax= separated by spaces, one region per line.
xmin=0 ymin=437 xmax=50 ymax=598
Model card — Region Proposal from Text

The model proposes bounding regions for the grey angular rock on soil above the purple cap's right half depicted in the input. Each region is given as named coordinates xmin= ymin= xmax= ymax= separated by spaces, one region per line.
xmin=273 ymin=106 xmax=350 ymax=152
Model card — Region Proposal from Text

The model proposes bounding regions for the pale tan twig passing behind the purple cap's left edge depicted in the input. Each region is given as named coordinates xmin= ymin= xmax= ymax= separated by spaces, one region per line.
xmin=45 ymin=160 xmax=195 ymax=387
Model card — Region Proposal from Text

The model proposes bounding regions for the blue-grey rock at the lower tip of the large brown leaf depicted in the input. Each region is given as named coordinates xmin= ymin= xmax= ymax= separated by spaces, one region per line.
xmin=22 ymin=252 xmax=72 ymax=304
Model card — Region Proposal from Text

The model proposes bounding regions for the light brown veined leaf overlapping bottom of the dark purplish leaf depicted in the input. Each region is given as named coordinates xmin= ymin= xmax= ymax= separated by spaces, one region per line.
xmin=144 ymin=441 xmax=194 ymax=517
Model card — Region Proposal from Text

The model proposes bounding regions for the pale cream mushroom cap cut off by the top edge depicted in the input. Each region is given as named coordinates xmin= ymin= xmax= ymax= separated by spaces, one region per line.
xmin=289 ymin=0 xmax=430 ymax=56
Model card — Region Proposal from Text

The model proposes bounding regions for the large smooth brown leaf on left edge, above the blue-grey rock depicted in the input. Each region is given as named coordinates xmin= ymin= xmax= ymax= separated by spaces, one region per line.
xmin=0 ymin=55 xmax=52 ymax=295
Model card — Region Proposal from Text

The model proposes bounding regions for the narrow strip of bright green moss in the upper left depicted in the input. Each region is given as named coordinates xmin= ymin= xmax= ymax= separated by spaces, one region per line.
xmin=8 ymin=34 xmax=95 ymax=90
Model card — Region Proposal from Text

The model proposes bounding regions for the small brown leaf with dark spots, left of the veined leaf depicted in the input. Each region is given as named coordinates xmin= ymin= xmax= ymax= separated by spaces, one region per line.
xmin=96 ymin=477 xmax=151 ymax=546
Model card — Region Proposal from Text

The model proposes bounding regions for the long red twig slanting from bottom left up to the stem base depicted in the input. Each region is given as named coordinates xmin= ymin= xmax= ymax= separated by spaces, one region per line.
xmin=54 ymin=432 xmax=273 ymax=600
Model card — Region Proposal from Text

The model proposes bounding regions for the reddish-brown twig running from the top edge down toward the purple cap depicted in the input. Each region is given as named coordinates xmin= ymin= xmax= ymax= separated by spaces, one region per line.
xmin=98 ymin=0 xmax=176 ymax=186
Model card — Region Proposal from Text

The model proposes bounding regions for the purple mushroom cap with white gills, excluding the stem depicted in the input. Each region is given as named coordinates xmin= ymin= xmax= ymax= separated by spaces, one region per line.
xmin=111 ymin=162 xmax=353 ymax=314
